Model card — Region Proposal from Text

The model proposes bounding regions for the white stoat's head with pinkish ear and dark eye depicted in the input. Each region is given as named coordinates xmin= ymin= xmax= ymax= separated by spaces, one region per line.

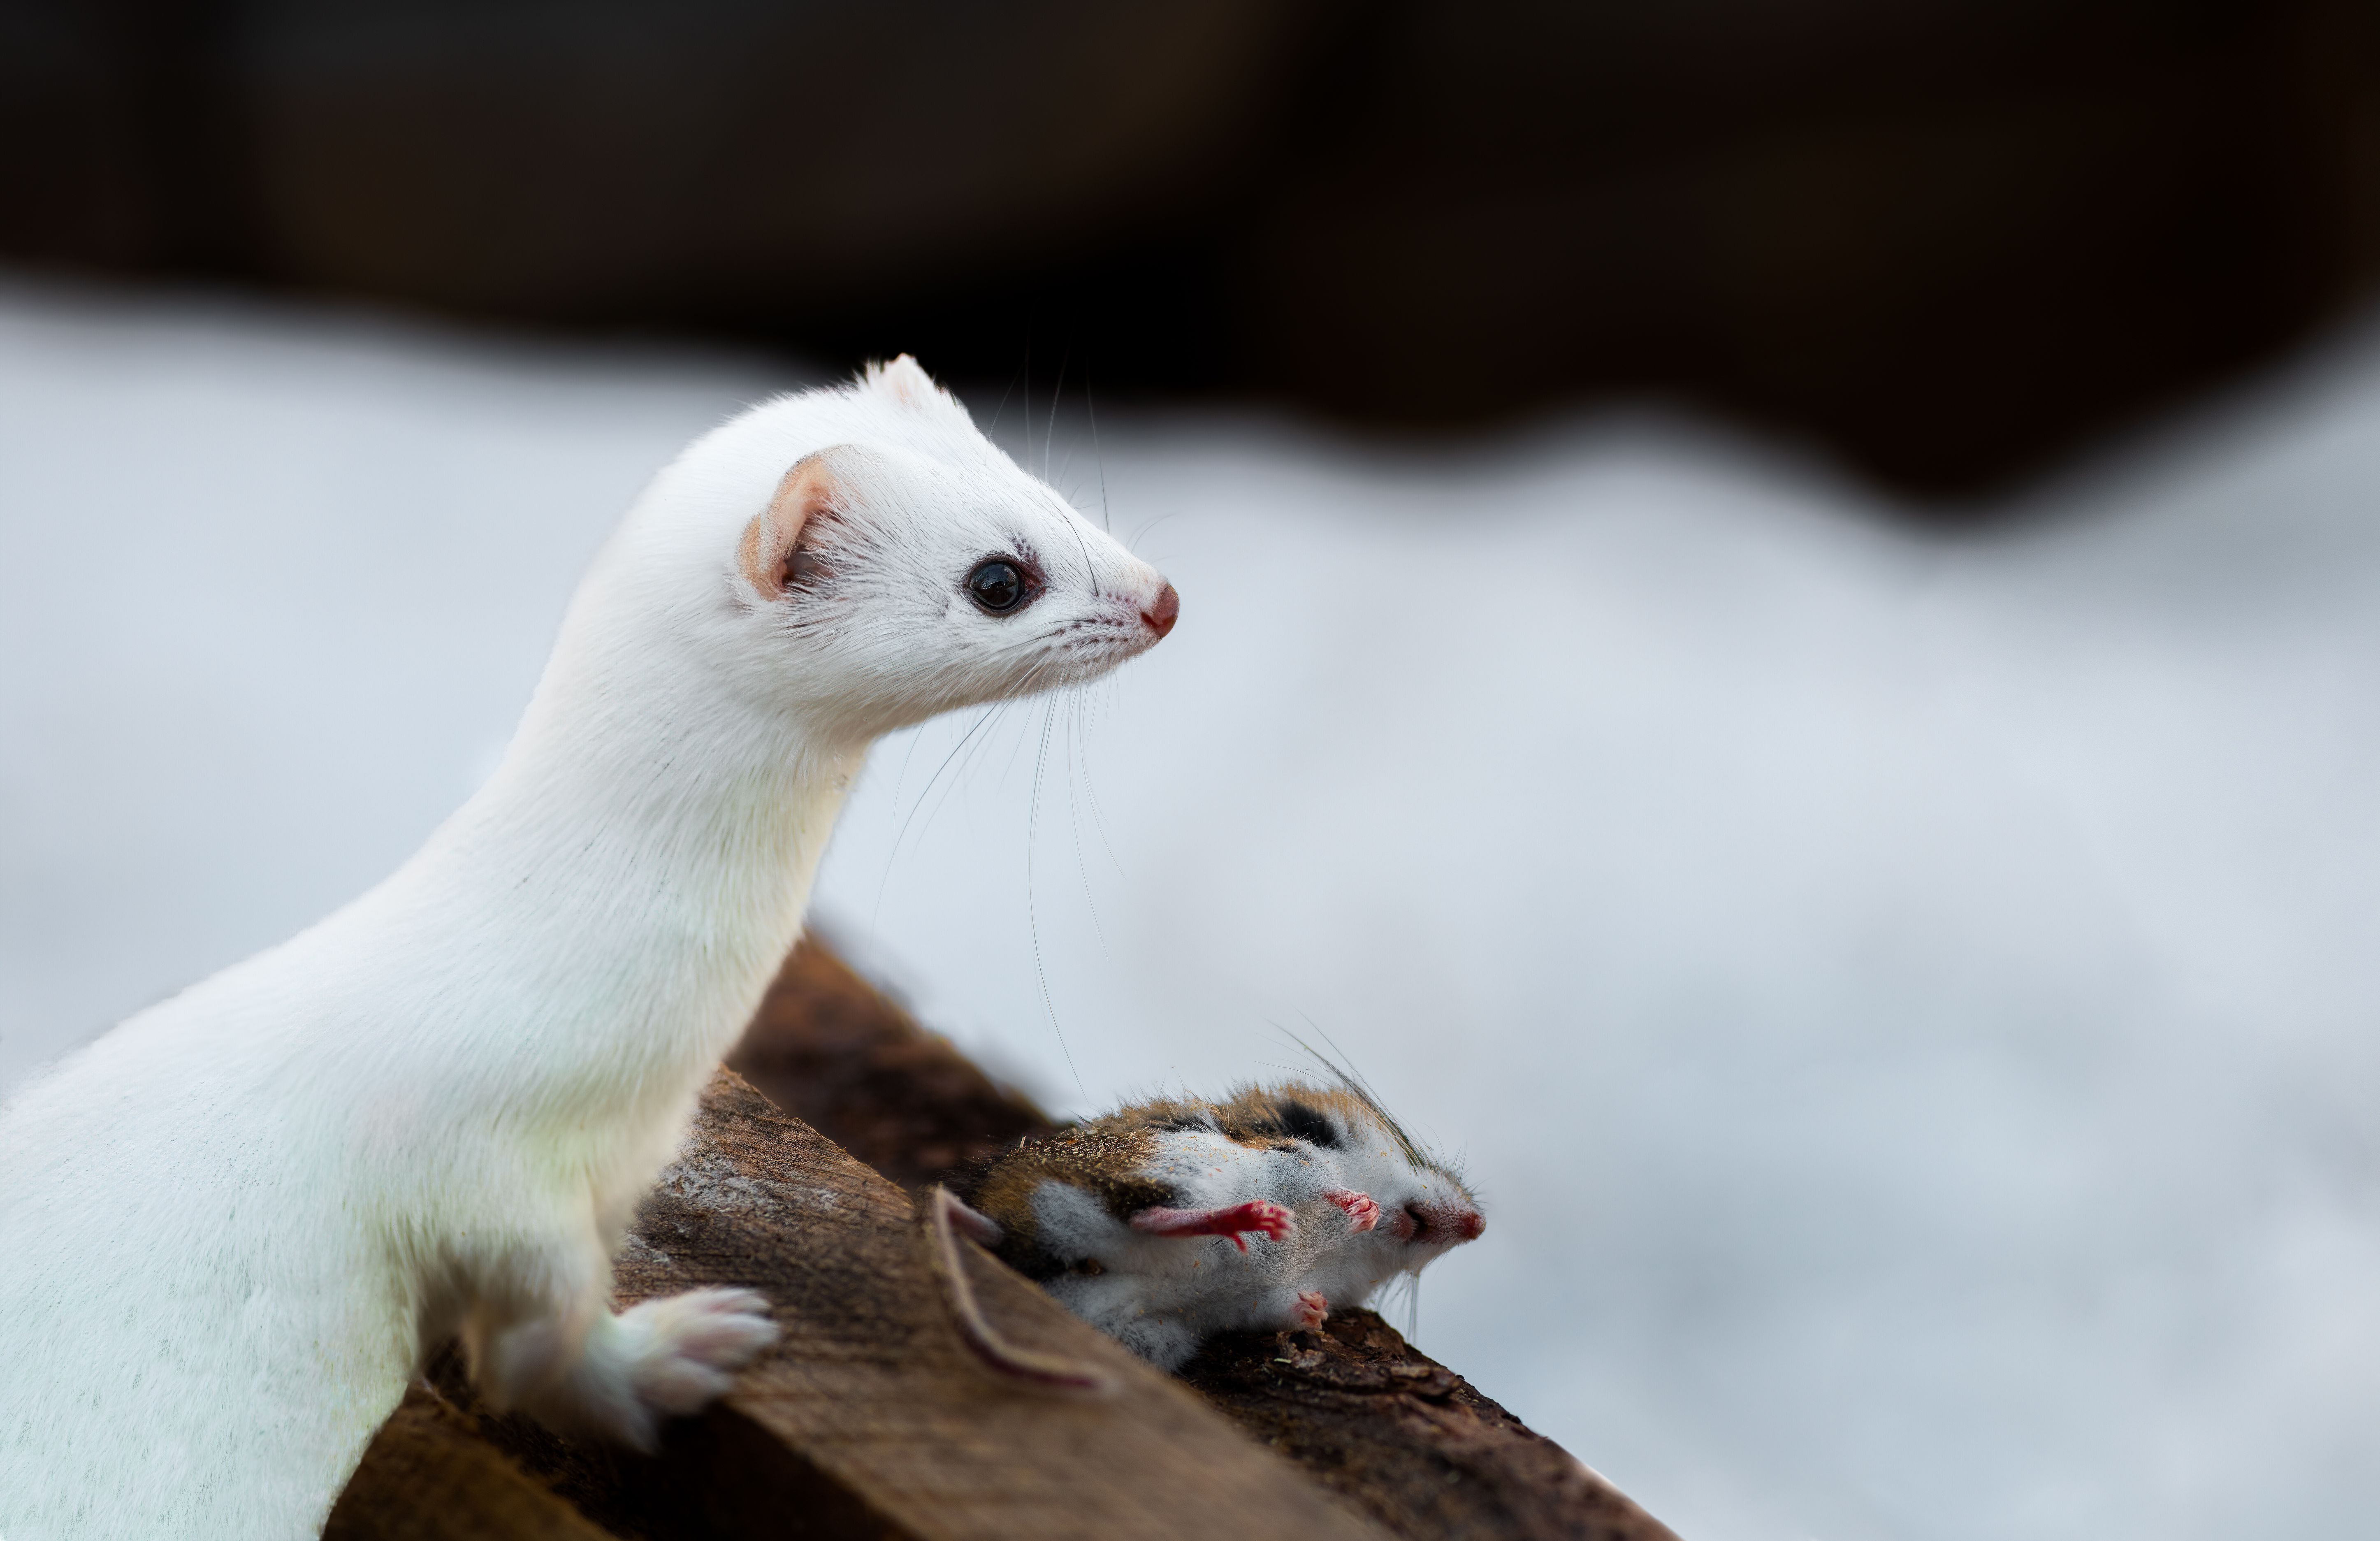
xmin=619 ymin=355 xmax=1181 ymax=738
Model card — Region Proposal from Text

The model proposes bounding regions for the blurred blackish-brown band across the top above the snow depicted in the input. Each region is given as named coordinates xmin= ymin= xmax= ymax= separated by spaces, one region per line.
xmin=0 ymin=0 xmax=2380 ymax=495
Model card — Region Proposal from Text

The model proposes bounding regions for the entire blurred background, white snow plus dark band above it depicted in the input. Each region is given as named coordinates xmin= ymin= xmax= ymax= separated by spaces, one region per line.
xmin=0 ymin=0 xmax=2380 ymax=1541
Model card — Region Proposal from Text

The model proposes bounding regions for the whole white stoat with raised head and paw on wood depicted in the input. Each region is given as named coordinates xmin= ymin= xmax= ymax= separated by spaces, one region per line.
xmin=0 ymin=357 xmax=1176 ymax=1541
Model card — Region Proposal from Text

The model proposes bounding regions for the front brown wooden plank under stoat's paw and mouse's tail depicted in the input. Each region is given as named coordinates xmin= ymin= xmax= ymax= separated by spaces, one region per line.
xmin=440 ymin=1070 xmax=1385 ymax=1541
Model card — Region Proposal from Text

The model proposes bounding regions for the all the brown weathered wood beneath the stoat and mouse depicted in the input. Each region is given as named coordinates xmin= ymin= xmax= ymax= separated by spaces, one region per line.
xmin=326 ymin=943 xmax=1671 ymax=1541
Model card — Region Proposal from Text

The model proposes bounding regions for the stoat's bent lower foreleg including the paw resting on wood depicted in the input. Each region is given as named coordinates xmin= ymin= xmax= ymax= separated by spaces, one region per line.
xmin=464 ymin=1253 xmax=776 ymax=1450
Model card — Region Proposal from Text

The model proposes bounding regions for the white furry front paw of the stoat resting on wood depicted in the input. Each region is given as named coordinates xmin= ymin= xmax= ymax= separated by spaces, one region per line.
xmin=561 ymin=1288 xmax=776 ymax=1453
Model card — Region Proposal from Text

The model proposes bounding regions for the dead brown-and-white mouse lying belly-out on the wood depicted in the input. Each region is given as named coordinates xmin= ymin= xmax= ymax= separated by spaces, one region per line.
xmin=959 ymin=1084 xmax=1485 ymax=1374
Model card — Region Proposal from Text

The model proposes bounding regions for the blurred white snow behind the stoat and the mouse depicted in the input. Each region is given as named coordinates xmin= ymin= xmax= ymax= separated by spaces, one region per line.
xmin=0 ymin=283 xmax=2380 ymax=1541
